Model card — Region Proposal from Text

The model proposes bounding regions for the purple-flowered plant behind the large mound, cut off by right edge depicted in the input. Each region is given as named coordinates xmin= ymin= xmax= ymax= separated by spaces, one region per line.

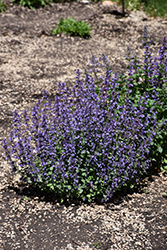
xmin=122 ymin=27 xmax=167 ymax=171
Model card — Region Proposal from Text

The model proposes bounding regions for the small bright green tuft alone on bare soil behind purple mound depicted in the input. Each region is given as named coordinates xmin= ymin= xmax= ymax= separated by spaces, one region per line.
xmin=52 ymin=17 xmax=91 ymax=38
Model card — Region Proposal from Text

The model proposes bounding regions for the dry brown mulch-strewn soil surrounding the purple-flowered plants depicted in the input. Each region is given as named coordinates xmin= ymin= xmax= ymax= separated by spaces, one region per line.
xmin=0 ymin=2 xmax=167 ymax=250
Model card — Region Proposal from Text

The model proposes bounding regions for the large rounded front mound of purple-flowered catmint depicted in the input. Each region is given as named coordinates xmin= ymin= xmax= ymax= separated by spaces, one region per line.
xmin=3 ymin=67 xmax=156 ymax=202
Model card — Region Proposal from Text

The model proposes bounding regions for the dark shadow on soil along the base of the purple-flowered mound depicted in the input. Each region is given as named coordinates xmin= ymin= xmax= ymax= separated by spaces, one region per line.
xmin=8 ymin=169 xmax=159 ymax=208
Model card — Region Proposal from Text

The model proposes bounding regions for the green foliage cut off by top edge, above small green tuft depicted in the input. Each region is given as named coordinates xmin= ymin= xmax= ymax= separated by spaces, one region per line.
xmin=13 ymin=0 xmax=51 ymax=9
